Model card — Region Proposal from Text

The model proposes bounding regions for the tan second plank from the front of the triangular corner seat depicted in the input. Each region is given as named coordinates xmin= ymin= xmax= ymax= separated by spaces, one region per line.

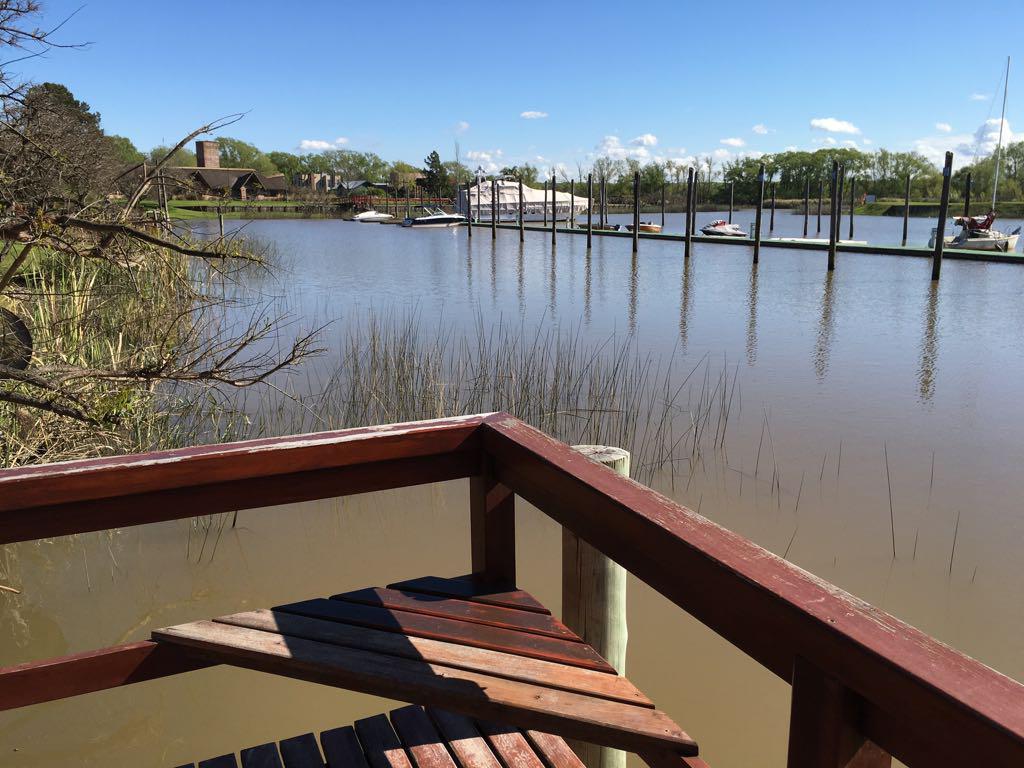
xmin=213 ymin=609 xmax=654 ymax=709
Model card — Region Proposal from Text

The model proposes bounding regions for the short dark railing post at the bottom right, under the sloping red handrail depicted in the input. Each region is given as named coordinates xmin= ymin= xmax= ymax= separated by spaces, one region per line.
xmin=786 ymin=656 xmax=892 ymax=768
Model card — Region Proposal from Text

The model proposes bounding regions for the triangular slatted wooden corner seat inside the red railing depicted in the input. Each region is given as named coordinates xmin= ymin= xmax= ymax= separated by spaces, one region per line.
xmin=153 ymin=577 xmax=697 ymax=757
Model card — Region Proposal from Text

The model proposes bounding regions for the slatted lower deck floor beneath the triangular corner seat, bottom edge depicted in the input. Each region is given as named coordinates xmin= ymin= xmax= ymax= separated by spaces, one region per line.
xmin=174 ymin=706 xmax=584 ymax=768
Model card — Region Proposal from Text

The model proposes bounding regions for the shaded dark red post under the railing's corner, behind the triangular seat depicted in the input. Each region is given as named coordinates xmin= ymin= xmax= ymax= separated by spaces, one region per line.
xmin=469 ymin=457 xmax=516 ymax=589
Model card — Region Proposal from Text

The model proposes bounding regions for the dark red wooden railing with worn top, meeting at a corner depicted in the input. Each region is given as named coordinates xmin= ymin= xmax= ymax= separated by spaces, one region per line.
xmin=0 ymin=414 xmax=1024 ymax=768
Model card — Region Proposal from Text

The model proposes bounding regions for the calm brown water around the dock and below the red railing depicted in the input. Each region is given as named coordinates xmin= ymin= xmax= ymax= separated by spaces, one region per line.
xmin=0 ymin=214 xmax=1024 ymax=768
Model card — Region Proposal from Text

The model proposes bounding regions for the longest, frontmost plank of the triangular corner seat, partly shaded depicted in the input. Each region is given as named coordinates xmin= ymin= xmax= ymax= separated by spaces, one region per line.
xmin=154 ymin=622 xmax=696 ymax=755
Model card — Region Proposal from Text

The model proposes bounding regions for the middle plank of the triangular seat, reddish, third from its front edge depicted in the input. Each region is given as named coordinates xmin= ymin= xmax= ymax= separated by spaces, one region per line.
xmin=273 ymin=598 xmax=614 ymax=674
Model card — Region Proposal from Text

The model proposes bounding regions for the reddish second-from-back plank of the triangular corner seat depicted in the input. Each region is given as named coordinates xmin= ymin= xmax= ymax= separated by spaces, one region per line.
xmin=331 ymin=587 xmax=583 ymax=642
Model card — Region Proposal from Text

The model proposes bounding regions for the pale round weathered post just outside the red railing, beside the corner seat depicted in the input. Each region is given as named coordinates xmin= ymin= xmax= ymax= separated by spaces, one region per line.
xmin=562 ymin=445 xmax=630 ymax=768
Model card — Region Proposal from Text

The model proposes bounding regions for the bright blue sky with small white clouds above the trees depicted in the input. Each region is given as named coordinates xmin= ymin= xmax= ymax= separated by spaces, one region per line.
xmin=14 ymin=0 xmax=1024 ymax=169
